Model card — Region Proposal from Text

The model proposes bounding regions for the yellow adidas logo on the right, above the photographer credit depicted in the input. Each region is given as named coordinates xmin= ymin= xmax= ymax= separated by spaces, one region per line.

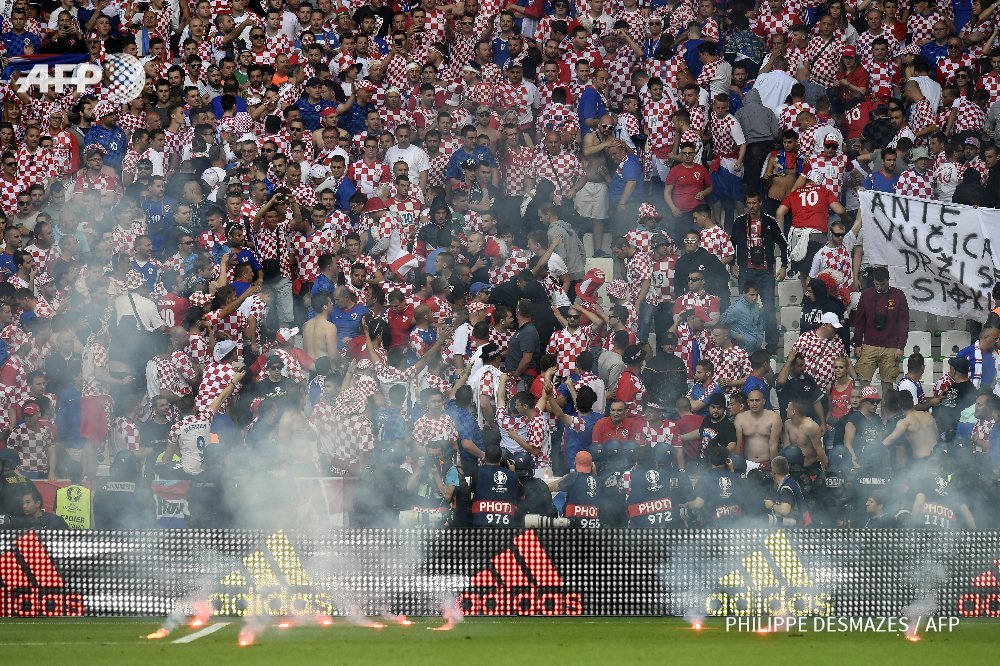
xmin=705 ymin=532 xmax=833 ymax=617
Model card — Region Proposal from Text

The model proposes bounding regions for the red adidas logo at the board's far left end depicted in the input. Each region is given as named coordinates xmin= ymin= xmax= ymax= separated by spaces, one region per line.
xmin=0 ymin=532 xmax=84 ymax=617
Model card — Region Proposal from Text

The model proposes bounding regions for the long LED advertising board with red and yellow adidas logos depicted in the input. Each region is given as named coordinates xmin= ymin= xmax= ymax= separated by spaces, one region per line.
xmin=0 ymin=529 xmax=1000 ymax=617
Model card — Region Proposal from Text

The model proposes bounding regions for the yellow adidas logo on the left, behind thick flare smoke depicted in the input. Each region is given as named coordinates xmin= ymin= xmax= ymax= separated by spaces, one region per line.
xmin=208 ymin=531 xmax=334 ymax=616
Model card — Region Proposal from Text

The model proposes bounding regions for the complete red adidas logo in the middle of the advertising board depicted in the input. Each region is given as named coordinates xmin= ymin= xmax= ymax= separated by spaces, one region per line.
xmin=458 ymin=531 xmax=583 ymax=615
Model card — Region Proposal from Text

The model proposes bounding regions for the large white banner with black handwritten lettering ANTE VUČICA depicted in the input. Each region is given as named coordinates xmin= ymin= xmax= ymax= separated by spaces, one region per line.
xmin=861 ymin=191 xmax=1000 ymax=321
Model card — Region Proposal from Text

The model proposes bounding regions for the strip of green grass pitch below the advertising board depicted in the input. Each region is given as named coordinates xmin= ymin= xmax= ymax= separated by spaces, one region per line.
xmin=0 ymin=618 xmax=1000 ymax=666
